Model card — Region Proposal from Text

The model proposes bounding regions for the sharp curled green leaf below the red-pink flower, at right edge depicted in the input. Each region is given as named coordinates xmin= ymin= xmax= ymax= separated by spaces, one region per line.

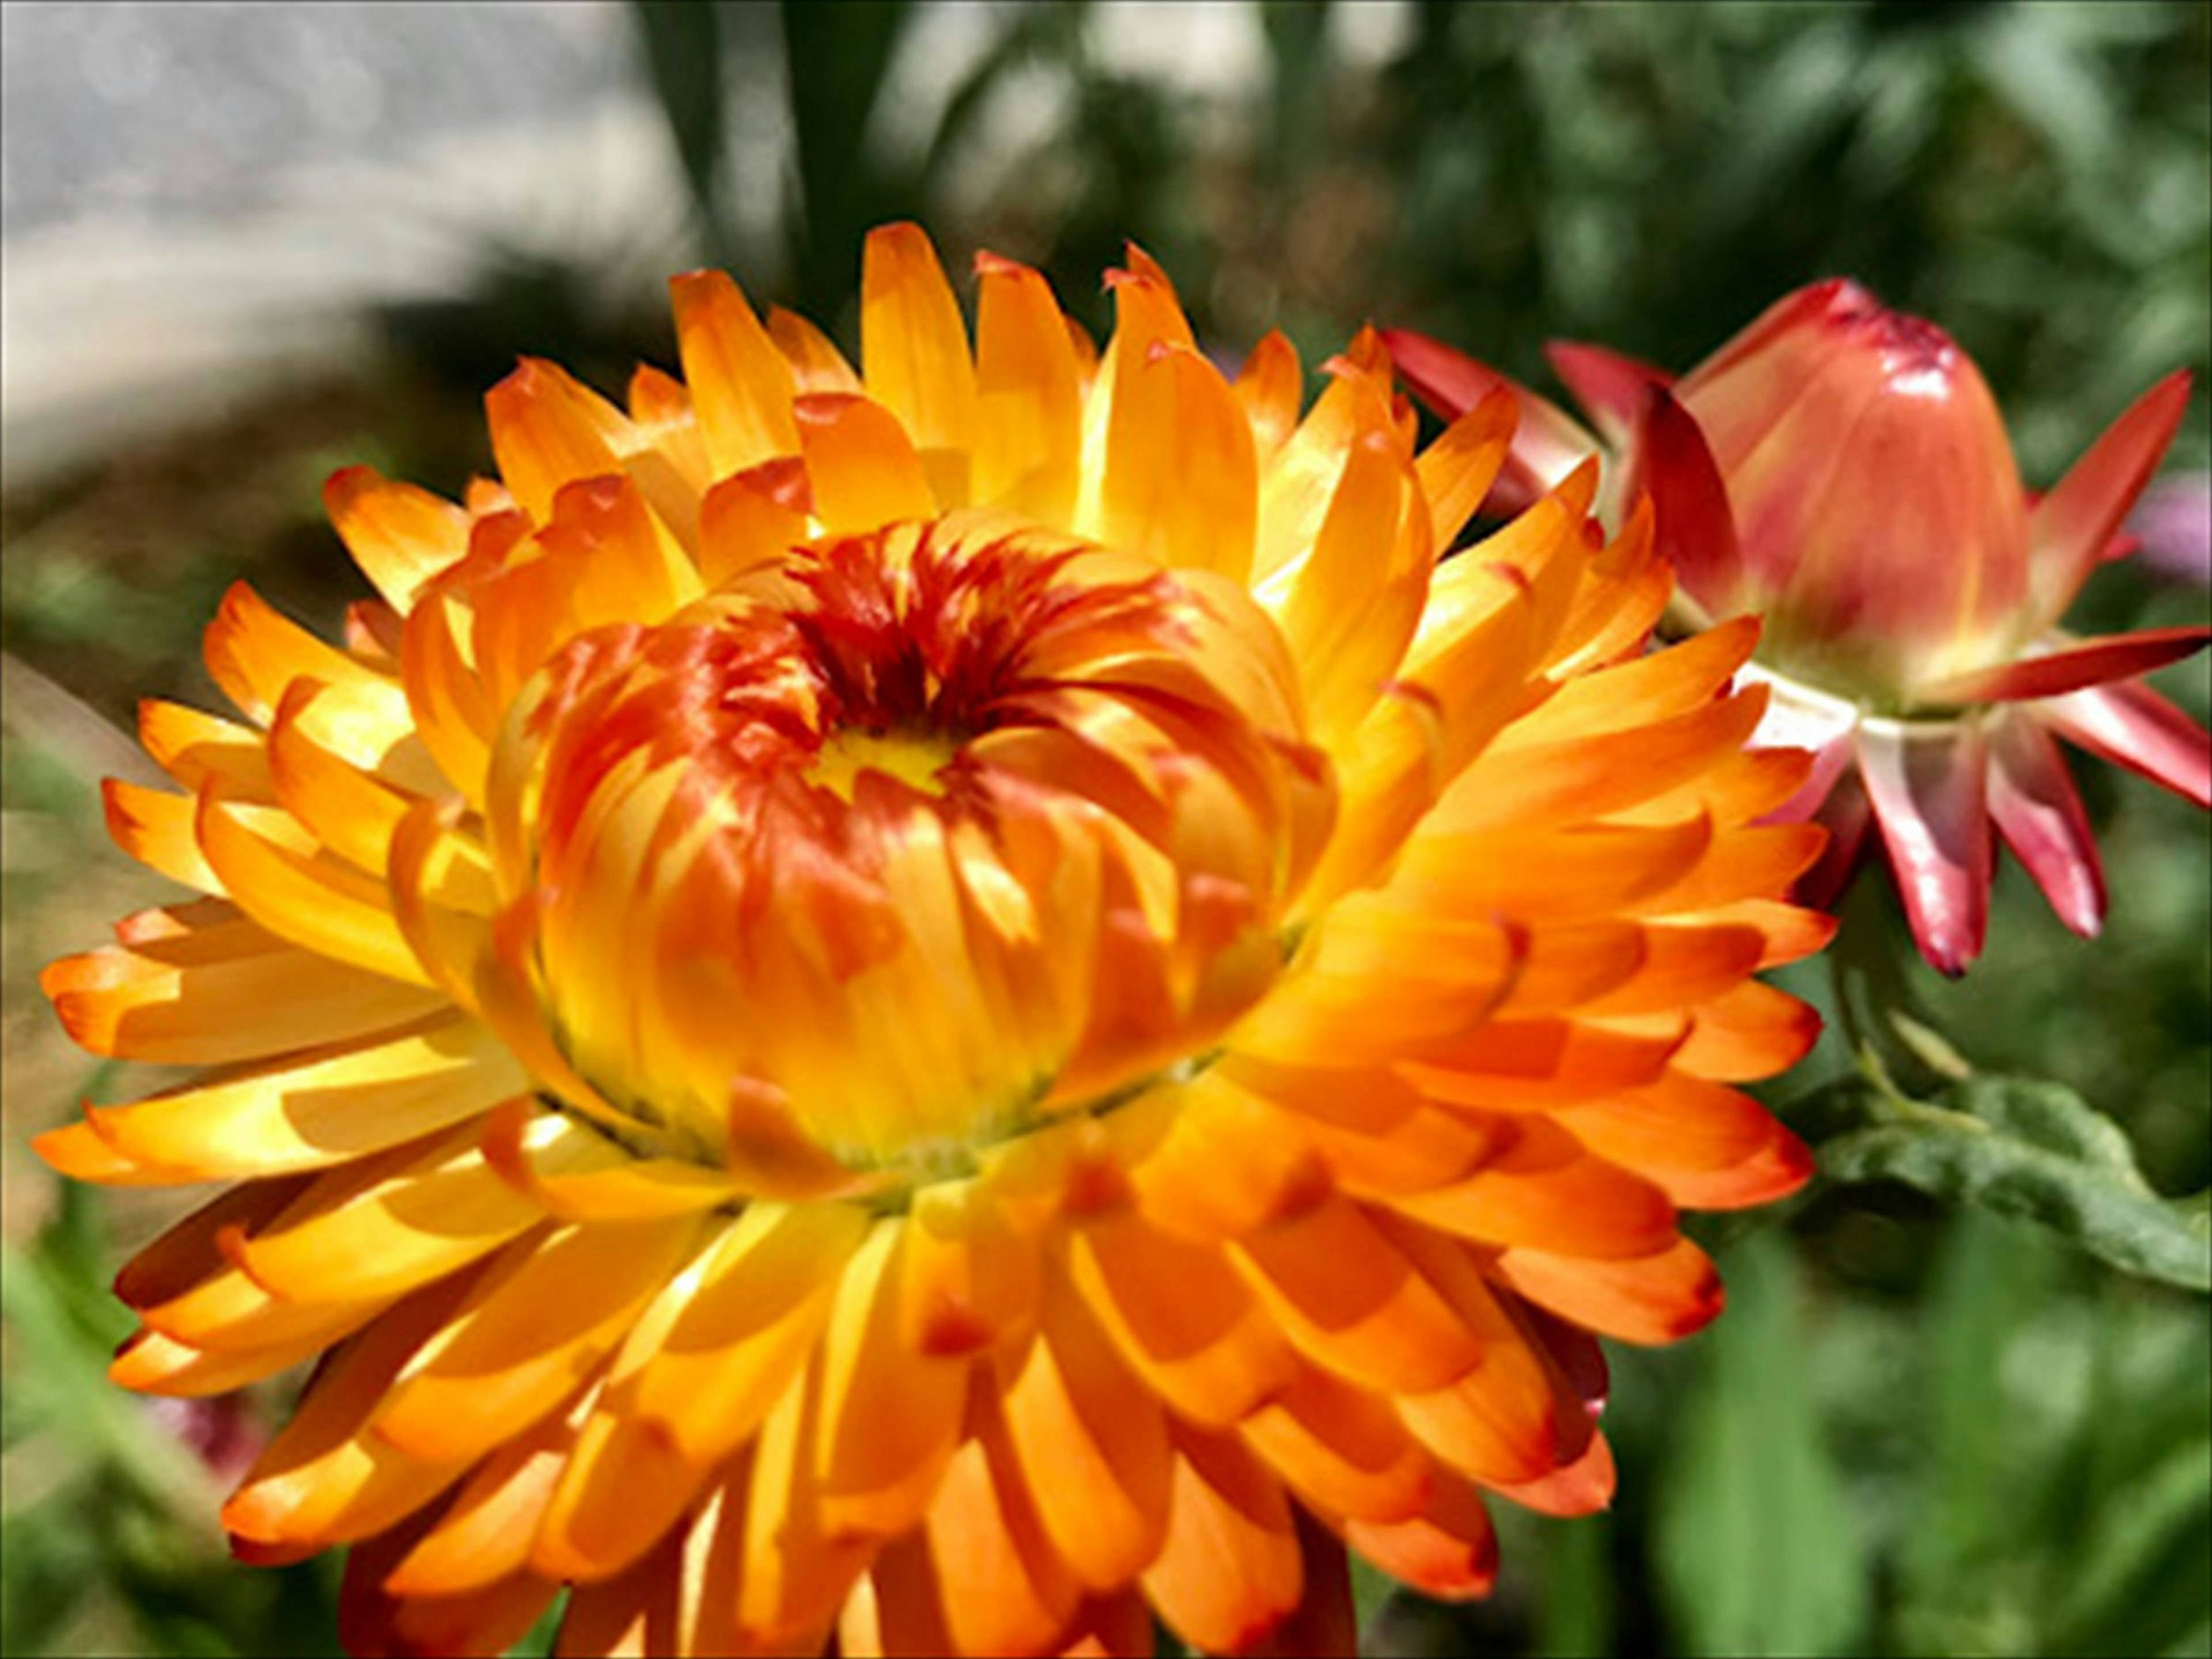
xmin=1818 ymin=1077 xmax=2212 ymax=1290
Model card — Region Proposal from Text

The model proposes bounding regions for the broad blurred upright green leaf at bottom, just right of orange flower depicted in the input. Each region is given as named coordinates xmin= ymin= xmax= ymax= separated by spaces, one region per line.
xmin=1654 ymin=1234 xmax=1867 ymax=1654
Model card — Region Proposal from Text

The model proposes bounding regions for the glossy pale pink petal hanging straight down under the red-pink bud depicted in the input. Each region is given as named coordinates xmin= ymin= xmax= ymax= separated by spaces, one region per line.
xmin=1858 ymin=721 xmax=1991 ymax=978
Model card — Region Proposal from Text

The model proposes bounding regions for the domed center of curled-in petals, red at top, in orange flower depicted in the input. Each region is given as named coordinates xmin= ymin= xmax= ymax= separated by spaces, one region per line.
xmin=491 ymin=524 xmax=1334 ymax=1177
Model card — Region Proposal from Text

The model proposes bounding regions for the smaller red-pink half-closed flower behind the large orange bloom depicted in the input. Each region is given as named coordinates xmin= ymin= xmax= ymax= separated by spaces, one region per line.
xmin=1385 ymin=281 xmax=2212 ymax=974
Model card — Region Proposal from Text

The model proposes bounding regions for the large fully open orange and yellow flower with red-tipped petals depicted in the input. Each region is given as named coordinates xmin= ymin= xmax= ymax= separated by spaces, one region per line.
xmin=40 ymin=226 xmax=1827 ymax=1654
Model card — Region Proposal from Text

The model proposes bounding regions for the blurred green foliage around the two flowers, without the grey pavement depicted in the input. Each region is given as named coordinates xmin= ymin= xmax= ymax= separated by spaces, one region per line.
xmin=0 ymin=0 xmax=2212 ymax=1654
